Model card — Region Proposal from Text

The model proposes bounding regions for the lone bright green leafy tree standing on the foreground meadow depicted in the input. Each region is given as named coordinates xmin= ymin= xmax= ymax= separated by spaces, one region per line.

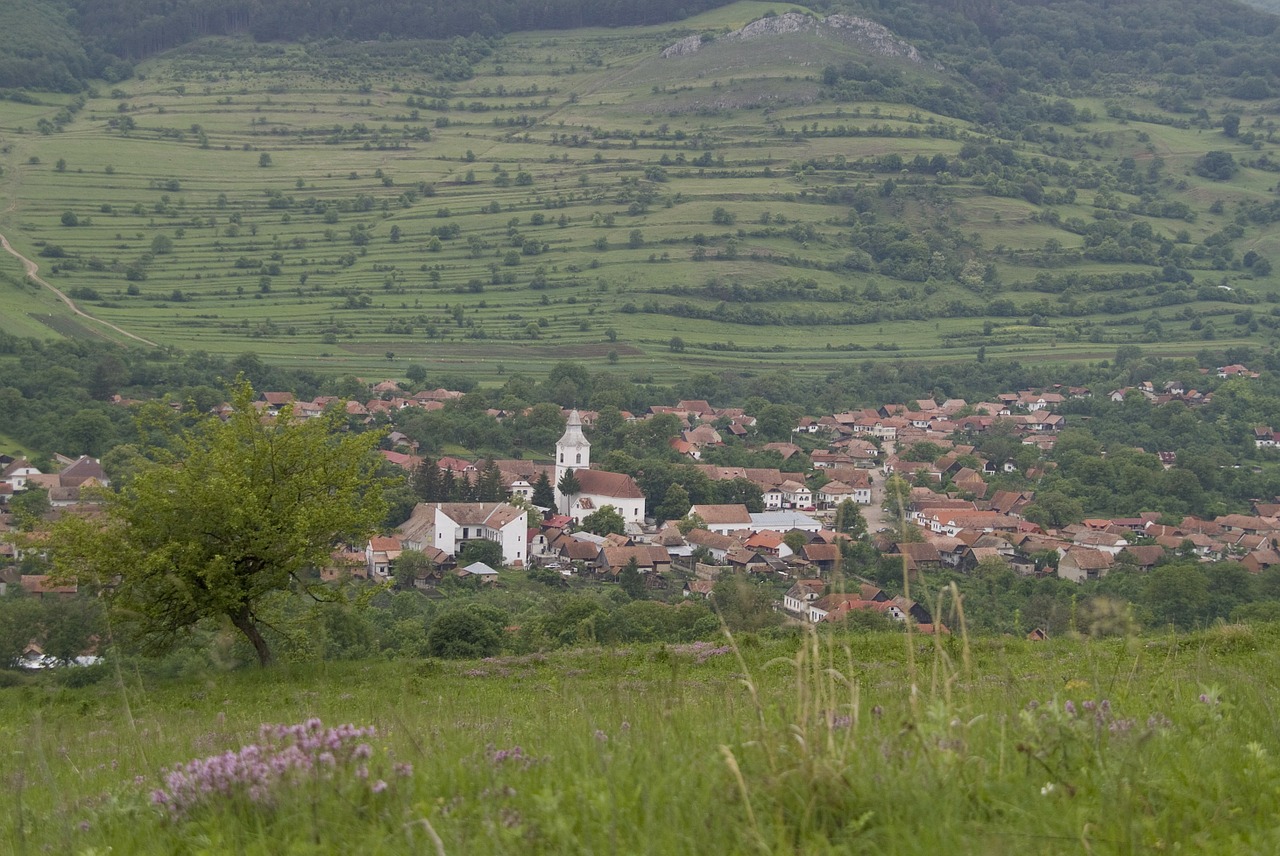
xmin=52 ymin=380 xmax=385 ymax=665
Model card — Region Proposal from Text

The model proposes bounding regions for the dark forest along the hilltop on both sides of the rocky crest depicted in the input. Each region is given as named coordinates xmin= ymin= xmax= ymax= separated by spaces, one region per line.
xmin=0 ymin=0 xmax=1280 ymax=93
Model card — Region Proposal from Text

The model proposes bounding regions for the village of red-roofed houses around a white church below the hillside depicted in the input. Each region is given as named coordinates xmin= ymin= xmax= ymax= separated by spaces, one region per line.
xmin=0 ymin=355 xmax=1280 ymax=647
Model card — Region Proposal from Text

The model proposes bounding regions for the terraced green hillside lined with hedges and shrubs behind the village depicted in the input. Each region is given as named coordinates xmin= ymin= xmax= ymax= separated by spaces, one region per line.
xmin=0 ymin=3 xmax=1280 ymax=381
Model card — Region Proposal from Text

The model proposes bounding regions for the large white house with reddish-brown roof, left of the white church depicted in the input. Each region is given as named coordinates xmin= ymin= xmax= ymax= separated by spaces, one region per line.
xmin=397 ymin=503 xmax=529 ymax=567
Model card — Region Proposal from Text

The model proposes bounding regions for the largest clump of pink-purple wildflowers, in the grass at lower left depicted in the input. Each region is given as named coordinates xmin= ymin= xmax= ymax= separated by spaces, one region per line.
xmin=151 ymin=718 xmax=373 ymax=818
